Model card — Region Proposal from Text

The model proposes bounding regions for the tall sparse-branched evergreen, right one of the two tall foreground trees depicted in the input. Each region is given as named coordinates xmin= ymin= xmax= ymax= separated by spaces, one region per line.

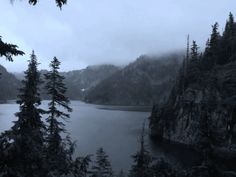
xmin=45 ymin=57 xmax=73 ymax=176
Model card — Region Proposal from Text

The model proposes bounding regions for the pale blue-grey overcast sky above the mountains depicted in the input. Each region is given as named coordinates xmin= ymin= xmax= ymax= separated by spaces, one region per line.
xmin=0 ymin=0 xmax=236 ymax=72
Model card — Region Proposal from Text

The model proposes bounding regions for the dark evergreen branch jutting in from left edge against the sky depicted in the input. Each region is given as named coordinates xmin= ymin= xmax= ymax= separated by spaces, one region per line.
xmin=0 ymin=36 xmax=24 ymax=61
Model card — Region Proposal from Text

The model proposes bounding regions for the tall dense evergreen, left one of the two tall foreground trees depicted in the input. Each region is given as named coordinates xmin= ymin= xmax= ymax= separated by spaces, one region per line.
xmin=0 ymin=52 xmax=45 ymax=177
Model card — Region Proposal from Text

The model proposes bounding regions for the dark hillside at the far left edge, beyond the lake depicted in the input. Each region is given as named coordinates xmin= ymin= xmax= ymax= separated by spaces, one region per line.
xmin=0 ymin=65 xmax=20 ymax=101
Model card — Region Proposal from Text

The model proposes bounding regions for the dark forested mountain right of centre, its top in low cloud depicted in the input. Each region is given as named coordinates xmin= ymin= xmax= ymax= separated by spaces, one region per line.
xmin=85 ymin=53 xmax=183 ymax=105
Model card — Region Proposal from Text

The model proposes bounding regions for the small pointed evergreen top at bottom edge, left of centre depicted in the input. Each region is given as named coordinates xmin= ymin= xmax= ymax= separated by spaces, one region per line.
xmin=91 ymin=148 xmax=113 ymax=177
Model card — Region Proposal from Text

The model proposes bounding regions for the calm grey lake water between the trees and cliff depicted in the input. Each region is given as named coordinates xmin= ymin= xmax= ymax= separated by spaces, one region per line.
xmin=0 ymin=101 xmax=200 ymax=171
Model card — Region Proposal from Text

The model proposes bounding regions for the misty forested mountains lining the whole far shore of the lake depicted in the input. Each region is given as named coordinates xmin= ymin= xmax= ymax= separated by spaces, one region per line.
xmin=0 ymin=52 xmax=181 ymax=106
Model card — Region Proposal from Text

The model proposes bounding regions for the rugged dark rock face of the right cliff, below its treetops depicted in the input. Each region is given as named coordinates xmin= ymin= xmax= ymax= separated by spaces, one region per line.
xmin=151 ymin=62 xmax=236 ymax=145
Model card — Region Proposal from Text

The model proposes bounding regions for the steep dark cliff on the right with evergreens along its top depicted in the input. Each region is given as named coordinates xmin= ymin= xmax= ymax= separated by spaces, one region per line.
xmin=150 ymin=14 xmax=236 ymax=147
